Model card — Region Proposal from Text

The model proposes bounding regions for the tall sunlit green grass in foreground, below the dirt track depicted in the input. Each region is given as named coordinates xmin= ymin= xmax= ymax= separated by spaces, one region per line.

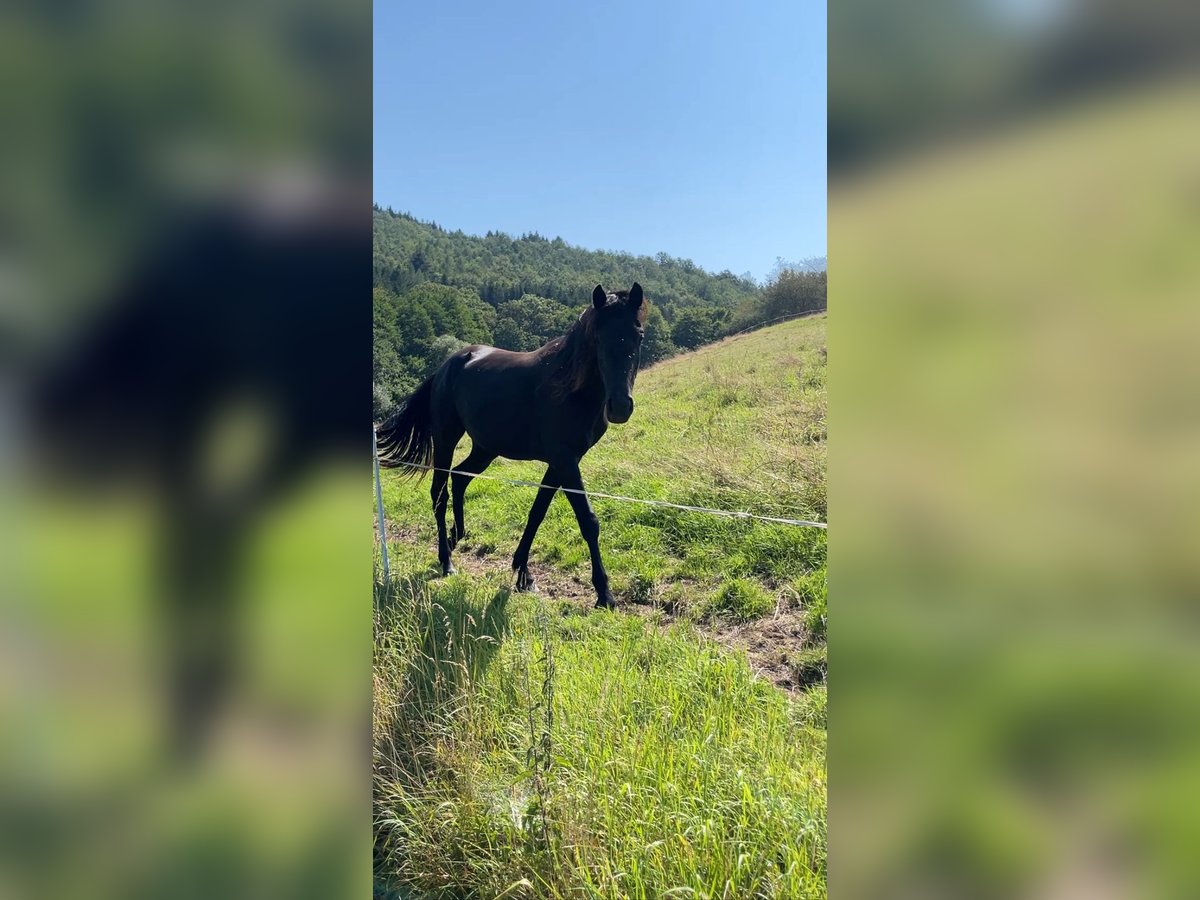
xmin=374 ymin=576 xmax=826 ymax=898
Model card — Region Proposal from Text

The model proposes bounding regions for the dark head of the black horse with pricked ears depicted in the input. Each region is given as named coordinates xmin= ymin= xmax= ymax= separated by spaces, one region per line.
xmin=592 ymin=282 xmax=646 ymax=424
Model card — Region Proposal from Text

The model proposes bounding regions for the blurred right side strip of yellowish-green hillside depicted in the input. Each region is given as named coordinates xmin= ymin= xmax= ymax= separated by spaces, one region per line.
xmin=829 ymin=2 xmax=1200 ymax=898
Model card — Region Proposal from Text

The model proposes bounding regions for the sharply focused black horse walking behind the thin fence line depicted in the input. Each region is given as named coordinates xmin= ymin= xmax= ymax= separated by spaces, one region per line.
xmin=377 ymin=283 xmax=646 ymax=608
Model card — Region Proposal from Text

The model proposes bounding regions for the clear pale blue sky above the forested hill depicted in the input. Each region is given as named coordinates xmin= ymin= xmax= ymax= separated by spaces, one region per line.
xmin=374 ymin=0 xmax=826 ymax=278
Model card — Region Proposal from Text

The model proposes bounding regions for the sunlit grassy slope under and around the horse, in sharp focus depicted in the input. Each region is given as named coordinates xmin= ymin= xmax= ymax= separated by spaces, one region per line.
xmin=374 ymin=316 xmax=826 ymax=898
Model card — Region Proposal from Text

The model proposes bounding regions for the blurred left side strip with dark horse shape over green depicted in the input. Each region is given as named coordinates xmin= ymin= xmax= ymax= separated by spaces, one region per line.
xmin=0 ymin=0 xmax=372 ymax=898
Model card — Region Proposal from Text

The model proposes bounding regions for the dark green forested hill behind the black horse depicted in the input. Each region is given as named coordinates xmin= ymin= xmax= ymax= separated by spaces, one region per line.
xmin=372 ymin=206 xmax=826 ymax=418
